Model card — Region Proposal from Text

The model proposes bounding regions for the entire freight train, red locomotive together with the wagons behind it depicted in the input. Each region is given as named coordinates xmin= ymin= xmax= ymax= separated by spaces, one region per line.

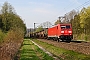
xmin=30 ymin=24 xmax=73 ymax=42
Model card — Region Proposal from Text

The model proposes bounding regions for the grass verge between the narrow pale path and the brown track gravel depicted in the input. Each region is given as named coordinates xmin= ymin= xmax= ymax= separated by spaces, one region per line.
xmin=33 ymin=39 xmax=90 ymax=60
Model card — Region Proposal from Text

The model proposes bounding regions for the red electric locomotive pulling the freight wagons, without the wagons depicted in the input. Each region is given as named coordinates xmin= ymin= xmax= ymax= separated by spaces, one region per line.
xmin=48 ymin=24 xmax=73 ymax=42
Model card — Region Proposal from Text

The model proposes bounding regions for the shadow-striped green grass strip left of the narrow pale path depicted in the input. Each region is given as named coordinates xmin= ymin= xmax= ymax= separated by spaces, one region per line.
xmin=20 ymin=39 xmax=54 ymax=60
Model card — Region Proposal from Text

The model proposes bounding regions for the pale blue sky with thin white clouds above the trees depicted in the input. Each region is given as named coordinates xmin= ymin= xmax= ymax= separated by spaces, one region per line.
xmin=0 ymin=0 xmax=90 ymax=28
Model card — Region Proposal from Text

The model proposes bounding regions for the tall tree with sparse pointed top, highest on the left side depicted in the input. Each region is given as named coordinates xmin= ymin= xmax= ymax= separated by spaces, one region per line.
xmin=1 ymin=2 xmax=15 ymax=31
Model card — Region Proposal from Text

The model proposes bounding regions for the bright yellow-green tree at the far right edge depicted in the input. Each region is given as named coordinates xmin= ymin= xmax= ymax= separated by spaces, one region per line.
xmin=80 ymin=6 xmax=90 ymax=34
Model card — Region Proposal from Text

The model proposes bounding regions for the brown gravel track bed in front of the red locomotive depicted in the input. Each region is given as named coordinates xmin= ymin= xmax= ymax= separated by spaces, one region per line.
xmin=38 ymin=39 xmax=90 ymax=55
